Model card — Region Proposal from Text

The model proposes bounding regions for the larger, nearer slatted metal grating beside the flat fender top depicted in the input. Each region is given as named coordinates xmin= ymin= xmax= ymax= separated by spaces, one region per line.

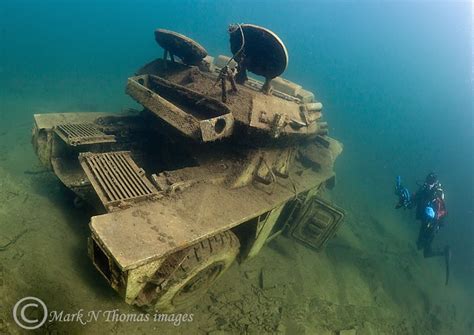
xmin=79 ymin=151 xmax=158 ymax=211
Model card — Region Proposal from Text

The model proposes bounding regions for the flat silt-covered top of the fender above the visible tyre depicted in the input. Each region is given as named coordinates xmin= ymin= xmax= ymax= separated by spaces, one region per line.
xmin=90 ymin=146 xmax=333 ymax=269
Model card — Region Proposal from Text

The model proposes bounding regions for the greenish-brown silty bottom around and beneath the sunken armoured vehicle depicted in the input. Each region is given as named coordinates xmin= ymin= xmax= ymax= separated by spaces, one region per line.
xmin=0 ymin=116 xmax=474 ymax=335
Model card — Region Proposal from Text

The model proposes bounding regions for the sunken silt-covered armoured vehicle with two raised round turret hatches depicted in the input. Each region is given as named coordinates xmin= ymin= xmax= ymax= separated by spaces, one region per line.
xmin=33 ymin=24 xmax=344 ymax=311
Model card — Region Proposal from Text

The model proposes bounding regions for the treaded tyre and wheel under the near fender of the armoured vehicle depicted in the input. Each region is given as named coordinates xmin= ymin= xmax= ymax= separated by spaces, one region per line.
xmin=137 ymin=231 xmax=240 ymax=312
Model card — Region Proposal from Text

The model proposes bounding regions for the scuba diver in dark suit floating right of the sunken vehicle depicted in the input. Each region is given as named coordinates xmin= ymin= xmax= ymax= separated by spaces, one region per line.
xmin=395 ymin=172 xmax=451 ymax=285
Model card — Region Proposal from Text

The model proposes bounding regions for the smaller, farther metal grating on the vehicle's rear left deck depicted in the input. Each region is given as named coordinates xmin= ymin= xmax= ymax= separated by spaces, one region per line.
xmin=55 ymin=123 xmax=115 ymax=146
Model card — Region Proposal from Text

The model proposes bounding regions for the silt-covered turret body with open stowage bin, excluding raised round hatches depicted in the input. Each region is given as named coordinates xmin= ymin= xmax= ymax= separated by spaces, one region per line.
xmin=127 ymin=66 xmax=322 ymax=138
